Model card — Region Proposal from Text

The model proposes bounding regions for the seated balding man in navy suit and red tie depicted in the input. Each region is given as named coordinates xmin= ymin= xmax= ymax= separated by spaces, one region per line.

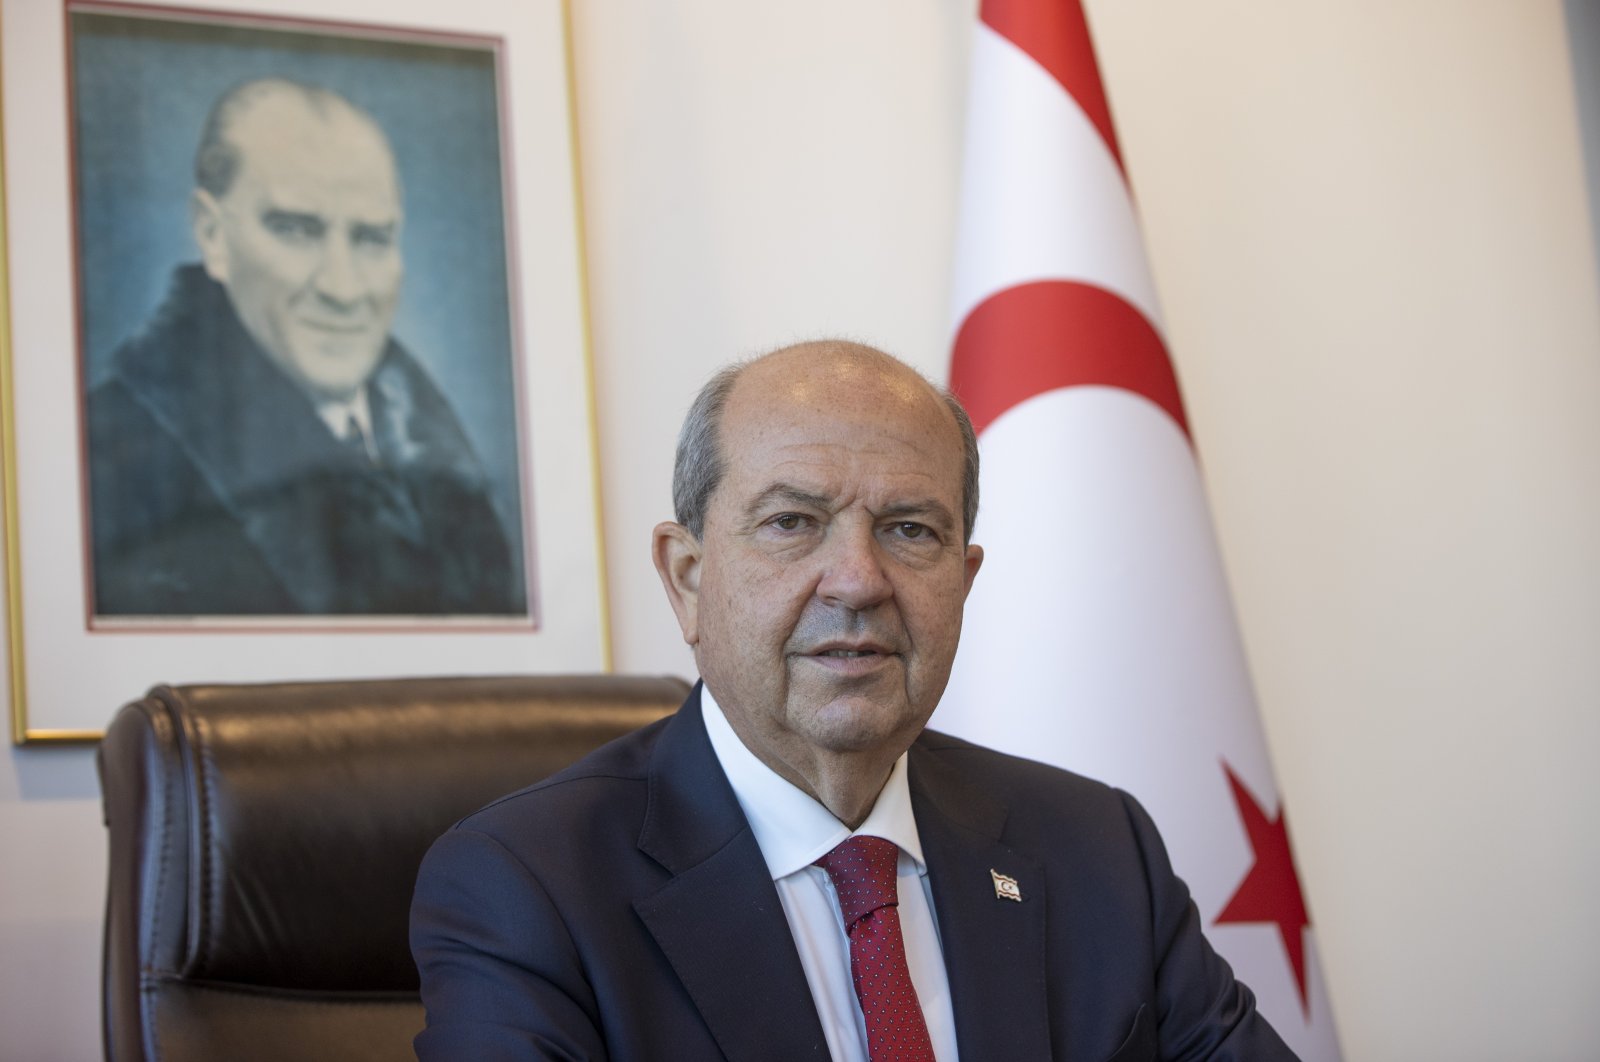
xmin=413 ymin=342 xmax=1293 ymax=1062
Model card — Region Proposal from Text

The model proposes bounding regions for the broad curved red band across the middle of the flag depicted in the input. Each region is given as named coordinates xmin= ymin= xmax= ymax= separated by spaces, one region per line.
xmin=950 ymin=280 xmax=1189 ymax=435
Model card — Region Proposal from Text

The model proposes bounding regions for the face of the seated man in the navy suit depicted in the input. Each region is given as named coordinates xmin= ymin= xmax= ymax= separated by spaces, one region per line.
xmin=656 ymin=349 xmax=982 ymax=793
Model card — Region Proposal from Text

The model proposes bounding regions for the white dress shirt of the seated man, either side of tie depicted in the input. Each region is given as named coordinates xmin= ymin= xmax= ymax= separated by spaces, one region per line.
xmin=701 ymin=685 xmax=955 ymax=1062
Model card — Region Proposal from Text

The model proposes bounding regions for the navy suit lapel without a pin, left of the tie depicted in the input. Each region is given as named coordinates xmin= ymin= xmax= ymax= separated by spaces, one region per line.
xmin=634 ymin=686 xmax=827 ymax=1062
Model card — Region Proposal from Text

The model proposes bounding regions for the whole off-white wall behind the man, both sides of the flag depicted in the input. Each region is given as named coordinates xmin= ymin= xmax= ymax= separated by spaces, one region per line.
xmin=0 ymin=0 xmax=1600 ymax=1060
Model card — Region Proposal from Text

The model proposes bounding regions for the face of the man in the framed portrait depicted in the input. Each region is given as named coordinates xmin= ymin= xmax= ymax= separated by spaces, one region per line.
xmin=195 ymin=94 xmax=403 ymax=398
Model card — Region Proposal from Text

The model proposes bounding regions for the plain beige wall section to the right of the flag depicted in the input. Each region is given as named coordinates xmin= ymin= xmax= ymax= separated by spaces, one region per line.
xmin=1094 ymin=0 xmax=1600 ymax=1059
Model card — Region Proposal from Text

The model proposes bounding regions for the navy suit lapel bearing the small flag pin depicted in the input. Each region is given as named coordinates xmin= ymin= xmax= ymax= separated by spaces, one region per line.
xmin=909 ymin=741 xmax=1050 ymax=1059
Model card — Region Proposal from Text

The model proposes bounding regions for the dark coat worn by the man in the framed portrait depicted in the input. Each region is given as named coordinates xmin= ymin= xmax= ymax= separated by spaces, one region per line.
xmin=90 ymin=266 xmax=525 ymax=616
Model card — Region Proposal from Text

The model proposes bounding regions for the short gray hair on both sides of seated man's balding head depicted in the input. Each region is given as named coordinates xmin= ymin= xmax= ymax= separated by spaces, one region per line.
xmin=672 ymin=352 xmax=978 ymax=545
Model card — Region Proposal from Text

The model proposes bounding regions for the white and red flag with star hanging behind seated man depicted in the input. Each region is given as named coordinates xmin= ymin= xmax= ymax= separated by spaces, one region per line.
xmin=933 ymin=0 xmax=1339 ymax=1062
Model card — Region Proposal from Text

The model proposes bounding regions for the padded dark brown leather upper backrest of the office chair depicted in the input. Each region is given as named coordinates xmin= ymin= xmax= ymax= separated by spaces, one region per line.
xmin=106 ymin=677 xmax=688 ymax=990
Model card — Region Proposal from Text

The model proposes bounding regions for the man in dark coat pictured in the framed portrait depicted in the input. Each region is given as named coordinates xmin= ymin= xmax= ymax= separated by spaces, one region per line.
xmin=90 ymin=78 xmax=526 ymax=616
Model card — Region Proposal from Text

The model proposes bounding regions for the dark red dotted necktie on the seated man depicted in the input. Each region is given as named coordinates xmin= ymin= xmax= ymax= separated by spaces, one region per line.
xmin=816 ymin=836 xmax=933 ymax=1062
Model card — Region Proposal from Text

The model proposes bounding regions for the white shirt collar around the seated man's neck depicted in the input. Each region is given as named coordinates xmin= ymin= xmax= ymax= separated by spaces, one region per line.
xmin=701 ymin=683 xmax=928 ymax=881
